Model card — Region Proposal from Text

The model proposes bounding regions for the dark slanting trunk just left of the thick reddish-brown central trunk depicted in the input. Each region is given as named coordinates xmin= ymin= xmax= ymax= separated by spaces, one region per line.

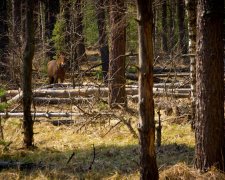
xmin=94 ymin=0 xmax=109 ymax=82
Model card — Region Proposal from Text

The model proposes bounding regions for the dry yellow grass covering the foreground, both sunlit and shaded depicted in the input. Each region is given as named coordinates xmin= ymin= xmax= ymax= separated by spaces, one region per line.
xmin=0 ymin=95 xmax=225 ymax=180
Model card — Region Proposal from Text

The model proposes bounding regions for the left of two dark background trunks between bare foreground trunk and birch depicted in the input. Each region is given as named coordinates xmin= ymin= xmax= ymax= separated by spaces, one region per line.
xmin=162 ymin=0 xmax=168 ymax=52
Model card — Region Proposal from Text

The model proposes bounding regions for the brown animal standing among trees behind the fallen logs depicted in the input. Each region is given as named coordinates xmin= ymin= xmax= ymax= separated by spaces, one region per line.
xmin=48 ymin=53 xmax=66 ymax=84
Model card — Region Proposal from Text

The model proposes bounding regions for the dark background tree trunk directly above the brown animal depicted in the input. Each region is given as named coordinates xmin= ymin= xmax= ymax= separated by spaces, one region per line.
xmin=46 ymin=0 xmax=60 ymax=59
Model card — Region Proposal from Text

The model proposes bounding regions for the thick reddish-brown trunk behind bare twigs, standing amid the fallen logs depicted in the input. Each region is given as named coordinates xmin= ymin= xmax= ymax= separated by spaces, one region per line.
xmin=108 ymin=0 xmax=127 ymax=108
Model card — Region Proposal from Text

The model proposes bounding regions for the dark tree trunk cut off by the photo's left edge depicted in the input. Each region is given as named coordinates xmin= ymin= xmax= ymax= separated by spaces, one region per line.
xmin=0 ymin=0 xmax=9 ymax=74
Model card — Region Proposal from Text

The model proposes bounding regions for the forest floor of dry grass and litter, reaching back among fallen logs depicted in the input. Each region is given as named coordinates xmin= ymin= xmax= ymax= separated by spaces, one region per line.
xmin=0 ymin=52 xmax=225 ymax=180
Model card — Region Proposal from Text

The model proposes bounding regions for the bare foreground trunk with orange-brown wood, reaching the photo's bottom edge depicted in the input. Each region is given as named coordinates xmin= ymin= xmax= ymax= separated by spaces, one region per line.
xmin=137 ymin=0 xmax=159 ymax=180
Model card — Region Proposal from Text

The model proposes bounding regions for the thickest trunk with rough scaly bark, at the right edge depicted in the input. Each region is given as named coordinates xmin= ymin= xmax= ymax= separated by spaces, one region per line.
xmin=195 ymin=0 xmax=225 ymax=171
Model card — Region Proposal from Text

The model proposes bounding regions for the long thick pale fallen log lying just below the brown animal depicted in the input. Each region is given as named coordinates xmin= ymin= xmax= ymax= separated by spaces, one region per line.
xmin=5 ymin=87 xmax=190 ymax=104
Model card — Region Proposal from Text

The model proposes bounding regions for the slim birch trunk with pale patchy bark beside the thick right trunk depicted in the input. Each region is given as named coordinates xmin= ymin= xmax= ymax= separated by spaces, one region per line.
xmin=186 ymin=0 xmax=197 ymax=128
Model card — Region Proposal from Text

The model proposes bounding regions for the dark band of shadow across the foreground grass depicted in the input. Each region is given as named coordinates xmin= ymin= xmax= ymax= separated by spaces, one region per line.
xmin=1 ymin=144 xmax=194 ymax=179
